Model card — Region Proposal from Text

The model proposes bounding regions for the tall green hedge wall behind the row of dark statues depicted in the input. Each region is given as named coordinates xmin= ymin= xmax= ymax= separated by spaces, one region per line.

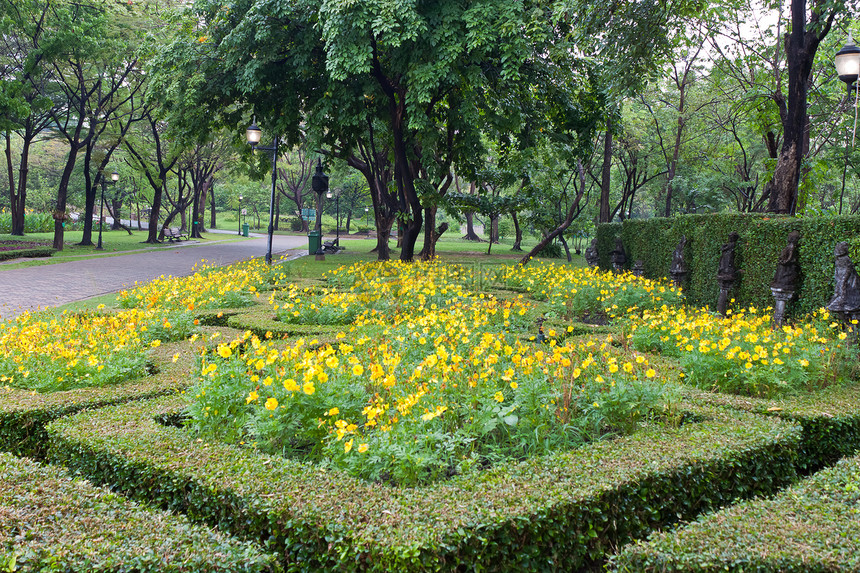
xmin=597 ymin=213 xmax=860 ymax=315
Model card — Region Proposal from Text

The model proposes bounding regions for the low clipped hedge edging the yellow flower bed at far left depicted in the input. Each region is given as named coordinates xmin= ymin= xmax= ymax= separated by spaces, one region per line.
xmin=0 ymin=327 xmax=236 ymax=459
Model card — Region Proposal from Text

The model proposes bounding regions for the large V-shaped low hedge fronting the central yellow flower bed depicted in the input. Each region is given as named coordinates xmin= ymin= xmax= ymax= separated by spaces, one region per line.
xmin=48 ymin=396 xmax=800 ymax=571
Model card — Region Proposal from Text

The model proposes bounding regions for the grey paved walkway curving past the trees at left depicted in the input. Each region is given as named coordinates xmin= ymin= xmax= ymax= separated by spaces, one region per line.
xmin=0 ymin=235 xmax=308 ymax=319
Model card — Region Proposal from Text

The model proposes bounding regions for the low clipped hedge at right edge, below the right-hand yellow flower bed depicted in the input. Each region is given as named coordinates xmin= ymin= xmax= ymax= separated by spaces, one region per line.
xmin=685 ymin=383 xmax=860 ymax=473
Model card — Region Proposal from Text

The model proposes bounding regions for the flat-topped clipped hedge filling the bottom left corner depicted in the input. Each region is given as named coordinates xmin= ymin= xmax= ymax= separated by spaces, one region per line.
xmin=0 ymin=453 xmax=279 ymax=573
